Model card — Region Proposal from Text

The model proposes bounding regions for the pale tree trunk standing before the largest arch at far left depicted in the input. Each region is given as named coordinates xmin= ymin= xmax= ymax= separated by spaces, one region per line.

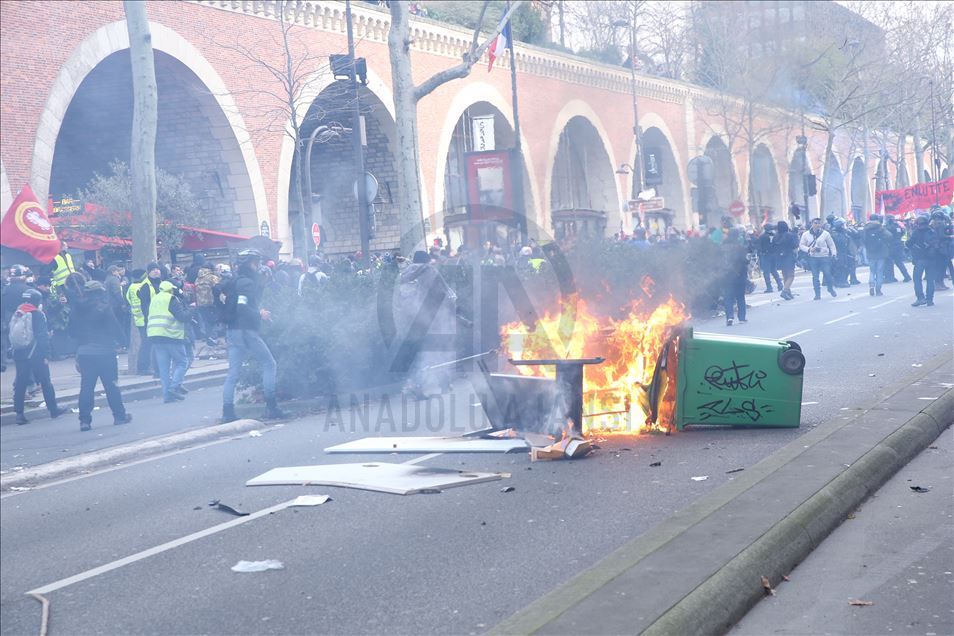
xmin=123 ymin=0 xmax=158 ymax=267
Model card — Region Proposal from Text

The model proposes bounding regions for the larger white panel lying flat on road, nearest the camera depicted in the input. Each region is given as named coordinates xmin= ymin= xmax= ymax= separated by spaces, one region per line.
xmin=245 ymin=463 xmax=503 ymax=495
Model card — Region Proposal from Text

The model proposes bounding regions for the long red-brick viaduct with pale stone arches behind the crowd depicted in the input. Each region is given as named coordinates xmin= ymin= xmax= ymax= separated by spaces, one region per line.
xmin=0 ymin=0 xmax=928 ymax=252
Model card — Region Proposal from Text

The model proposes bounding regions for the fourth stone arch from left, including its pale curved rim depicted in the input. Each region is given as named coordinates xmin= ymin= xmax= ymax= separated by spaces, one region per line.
xmin=544 ymin=99 xmax=622 ymax=240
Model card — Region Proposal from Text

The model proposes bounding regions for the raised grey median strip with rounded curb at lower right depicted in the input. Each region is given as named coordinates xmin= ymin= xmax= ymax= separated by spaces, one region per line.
xmin=491 ymin=352 xmax=954 ymax=634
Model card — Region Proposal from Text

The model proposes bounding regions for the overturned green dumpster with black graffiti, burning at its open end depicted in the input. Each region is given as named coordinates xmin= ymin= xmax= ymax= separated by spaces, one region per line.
xmin=649 ymin=328 xmax=805 ymax=430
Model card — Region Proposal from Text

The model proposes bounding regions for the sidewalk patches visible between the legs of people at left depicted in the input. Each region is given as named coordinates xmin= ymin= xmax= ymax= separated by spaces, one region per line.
xmin=0 ymin=347 xmax=229 ymax=425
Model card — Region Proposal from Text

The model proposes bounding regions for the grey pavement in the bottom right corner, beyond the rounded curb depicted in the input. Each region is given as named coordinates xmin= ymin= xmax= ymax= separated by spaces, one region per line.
xmin=731 ymin=429 xmax=954 ymax=636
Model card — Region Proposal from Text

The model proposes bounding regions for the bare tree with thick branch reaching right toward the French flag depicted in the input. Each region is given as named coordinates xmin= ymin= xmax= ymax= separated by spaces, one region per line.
xmin=388 ymin=0 xmax=521 ymax=254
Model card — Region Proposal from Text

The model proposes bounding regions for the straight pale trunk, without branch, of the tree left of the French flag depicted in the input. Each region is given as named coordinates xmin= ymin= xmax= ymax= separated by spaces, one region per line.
xmin=388 ymin=2 xmax=426 ymax=256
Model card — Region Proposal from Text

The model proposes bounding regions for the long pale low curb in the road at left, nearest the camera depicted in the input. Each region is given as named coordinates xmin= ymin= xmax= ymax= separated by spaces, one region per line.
xmin=0 ymin=419 xmax=268 ymax=491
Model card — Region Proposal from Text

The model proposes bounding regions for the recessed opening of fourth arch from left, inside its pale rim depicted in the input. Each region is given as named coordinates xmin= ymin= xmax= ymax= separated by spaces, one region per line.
xmin=550 ymin=116 xmax=622 ymax=239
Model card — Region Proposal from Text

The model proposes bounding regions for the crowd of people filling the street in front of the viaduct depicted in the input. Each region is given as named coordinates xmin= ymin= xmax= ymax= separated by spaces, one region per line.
xmin=0 ymin=209 xmax=954 ymax=431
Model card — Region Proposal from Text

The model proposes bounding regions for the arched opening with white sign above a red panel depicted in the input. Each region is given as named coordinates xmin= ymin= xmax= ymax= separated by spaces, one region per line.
xmin=437 ymin=102 xmax=539 ymax=249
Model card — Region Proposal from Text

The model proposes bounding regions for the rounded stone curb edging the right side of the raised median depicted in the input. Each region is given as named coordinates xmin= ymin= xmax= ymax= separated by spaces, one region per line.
xmin=643 ymin=389 xmax=954 ymax=636
